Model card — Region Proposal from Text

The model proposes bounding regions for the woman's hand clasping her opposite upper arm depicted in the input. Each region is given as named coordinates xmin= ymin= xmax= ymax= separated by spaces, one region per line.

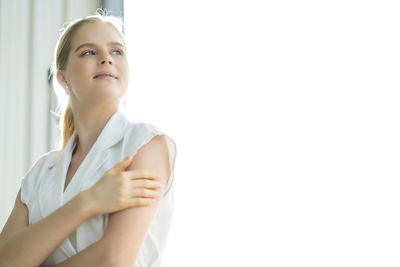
xmin=85 ymin=156 xmax=161 ymax=217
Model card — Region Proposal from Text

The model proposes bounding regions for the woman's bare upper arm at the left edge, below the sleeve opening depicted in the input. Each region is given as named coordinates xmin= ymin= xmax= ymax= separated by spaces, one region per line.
xmin=0 ymin=189 xmax=29 ymax=247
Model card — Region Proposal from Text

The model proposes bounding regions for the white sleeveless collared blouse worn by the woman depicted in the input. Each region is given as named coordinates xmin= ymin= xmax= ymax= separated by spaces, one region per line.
xmin=21 ymin=111 xmax=176 ymax=267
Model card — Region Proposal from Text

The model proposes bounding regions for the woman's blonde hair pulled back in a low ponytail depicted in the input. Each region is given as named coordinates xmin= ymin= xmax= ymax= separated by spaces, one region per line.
xmin=51 ymin=9 xmax=126 ymax=149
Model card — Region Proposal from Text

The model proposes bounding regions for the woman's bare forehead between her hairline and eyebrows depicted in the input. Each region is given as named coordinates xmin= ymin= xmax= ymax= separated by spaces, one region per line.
xmin=71 ymin=22 xmax=124 ymax=50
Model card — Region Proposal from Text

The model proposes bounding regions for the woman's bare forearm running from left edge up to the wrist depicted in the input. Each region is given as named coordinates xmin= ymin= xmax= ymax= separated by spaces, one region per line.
xmin=0 ymin=192 xmax=92 ymax=267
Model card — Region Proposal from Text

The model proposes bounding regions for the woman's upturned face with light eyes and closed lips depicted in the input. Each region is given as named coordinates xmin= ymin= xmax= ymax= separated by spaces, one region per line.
xmin=58 ymin=22 xmax=129 ymax=107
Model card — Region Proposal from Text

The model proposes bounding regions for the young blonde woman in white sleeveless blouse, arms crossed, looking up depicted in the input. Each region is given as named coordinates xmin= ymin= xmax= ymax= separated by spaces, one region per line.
xmin=0 ymin=12 xmax=176 ymax=267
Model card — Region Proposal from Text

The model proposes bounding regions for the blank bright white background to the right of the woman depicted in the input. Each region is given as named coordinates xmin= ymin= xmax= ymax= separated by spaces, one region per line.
xmin=125 ymin=0 xmax=400 ymax=267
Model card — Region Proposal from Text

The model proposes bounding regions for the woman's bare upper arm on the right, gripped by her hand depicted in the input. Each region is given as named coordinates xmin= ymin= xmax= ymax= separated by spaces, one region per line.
xmin=101 ymin=135 xmax=170 ymax=266
